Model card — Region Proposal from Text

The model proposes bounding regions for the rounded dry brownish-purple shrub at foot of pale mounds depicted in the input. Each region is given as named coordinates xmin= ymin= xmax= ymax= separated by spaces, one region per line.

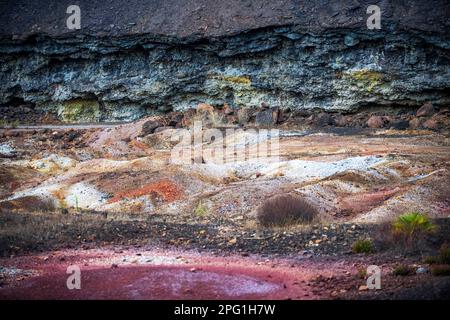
xmin=257 ymin=194 xmax=317 ymax=227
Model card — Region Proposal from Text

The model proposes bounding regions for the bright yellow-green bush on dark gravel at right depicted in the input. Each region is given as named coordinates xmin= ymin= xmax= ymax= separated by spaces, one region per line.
xmin=392 ymin=212 xmax=436 ymax=245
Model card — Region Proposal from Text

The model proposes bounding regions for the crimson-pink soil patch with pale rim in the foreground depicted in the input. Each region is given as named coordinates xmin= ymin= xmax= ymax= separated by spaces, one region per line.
xmin=0 ymin=251 xmax=318 ymax=300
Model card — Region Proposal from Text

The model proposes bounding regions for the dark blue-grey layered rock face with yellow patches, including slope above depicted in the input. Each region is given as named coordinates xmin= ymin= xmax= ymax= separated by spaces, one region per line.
xmin=0 ymin=0 xmax=450 ymax=122
